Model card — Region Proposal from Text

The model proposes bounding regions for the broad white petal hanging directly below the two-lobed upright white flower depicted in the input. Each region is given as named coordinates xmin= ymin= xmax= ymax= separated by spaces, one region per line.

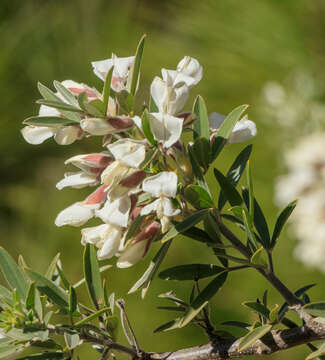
xmin=150 ymin=113 xmax=183 ymax=148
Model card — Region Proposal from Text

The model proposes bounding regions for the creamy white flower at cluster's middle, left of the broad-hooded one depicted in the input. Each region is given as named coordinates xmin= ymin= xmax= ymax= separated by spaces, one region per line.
xmin=101 ymin=139 xmax=146 ymax=187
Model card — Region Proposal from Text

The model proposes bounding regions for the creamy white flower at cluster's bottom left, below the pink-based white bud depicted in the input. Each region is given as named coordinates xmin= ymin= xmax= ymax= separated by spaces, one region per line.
xmin=81 ymin=224 xmax=123 ymax=260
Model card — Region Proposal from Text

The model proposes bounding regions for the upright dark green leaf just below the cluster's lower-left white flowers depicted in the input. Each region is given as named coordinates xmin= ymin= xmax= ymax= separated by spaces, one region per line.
xmin=84 ymin=244 xmax=104 ymax=309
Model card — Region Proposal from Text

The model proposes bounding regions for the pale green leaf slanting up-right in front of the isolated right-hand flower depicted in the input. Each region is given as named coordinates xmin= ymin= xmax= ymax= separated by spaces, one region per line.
xmin=211 ymin=105 xmax=248 ymax=162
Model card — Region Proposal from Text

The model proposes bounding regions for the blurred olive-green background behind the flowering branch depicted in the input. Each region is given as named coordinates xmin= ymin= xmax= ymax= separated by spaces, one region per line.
xmin=0 ymin=0 xmax=325 ymax=360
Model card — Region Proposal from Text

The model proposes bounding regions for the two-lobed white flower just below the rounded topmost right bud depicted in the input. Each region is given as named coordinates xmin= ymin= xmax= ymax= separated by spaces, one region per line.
xmin=150 ymin=76 xmax=189 ymax=115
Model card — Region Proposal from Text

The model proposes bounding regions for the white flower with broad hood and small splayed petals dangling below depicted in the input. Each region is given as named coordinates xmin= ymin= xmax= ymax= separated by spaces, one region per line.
xmin=141 ymin=171 xmax=180 ymax=233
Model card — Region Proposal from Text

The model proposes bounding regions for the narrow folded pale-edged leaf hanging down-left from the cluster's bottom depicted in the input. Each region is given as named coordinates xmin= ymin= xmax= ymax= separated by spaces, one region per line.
xmin=128 ymin=240 xmax=171 ymax=298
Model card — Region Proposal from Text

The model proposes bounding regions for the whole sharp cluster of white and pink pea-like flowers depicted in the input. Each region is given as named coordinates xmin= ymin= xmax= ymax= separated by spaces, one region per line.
xmin=22 ymin=40 xmax=256 ymax=268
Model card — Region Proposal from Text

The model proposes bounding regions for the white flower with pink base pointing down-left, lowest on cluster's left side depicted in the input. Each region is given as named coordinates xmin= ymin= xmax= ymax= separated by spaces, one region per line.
xmin=55 ymin=185 xmax=107 ymax=227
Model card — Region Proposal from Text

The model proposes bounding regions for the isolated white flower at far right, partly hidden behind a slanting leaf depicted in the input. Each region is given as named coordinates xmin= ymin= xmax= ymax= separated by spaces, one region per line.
xmin=209 ymin=112 xmax=257 ymax=144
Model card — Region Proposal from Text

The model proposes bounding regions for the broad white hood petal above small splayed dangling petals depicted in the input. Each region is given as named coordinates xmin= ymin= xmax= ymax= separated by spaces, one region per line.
xmin=142 ymin=171 xmax=177 ymax=198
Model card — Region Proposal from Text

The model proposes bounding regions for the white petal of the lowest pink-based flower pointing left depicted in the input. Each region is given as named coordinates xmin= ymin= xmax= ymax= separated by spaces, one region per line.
xmin=55 ymin=202 xmax=96 ymax=226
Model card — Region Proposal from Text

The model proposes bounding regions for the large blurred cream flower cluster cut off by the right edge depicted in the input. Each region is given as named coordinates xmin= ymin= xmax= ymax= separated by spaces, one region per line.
xmin=276 ymin=133 xmax=325 ymax=272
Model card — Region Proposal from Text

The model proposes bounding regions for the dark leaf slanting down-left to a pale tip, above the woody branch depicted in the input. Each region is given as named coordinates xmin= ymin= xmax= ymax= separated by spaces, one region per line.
xmin=178 ymin=272 xmax=228 ymax=327
